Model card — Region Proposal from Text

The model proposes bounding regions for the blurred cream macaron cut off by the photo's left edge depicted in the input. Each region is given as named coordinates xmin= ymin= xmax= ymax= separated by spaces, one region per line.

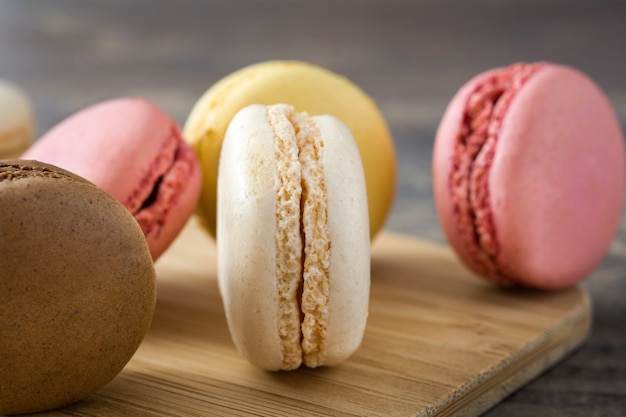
xmin=0 ymin=80 xmax=35 ymax=159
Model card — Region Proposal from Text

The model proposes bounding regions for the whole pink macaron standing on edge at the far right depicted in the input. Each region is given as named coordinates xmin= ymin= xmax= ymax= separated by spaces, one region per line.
xmin=433 ymin=62 xmax=624 ymax=289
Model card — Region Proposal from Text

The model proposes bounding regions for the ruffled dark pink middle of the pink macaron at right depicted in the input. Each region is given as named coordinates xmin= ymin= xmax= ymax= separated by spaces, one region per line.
xmin=449 ymin=63 xmax=544 ymax=285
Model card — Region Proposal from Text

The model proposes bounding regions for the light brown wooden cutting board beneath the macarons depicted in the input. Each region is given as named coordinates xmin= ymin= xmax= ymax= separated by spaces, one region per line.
xmin=30 ymin=219 xmax=591 ymax=416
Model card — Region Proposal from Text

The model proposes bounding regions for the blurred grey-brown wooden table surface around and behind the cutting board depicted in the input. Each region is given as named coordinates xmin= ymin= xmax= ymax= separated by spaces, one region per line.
xmin=0 ymin=0 xmax=626 ymax=416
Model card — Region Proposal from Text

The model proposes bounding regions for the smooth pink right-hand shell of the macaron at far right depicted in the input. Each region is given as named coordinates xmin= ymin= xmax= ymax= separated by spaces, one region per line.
xmin=489 ymin=65 xmax=624 ymax=288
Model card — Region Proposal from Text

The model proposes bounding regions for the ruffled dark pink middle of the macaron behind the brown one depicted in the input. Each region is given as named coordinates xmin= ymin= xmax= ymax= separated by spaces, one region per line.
xmin=123 ymin=126 xmax=195 ymax=237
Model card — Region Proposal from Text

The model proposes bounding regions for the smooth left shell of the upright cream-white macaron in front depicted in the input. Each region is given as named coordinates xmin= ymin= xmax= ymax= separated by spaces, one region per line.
xmin=217 ymin=105 xmax=282 ymax=370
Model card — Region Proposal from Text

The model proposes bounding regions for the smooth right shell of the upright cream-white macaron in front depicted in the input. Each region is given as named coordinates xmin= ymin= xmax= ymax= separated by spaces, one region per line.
xmin=316 ymin=115 xmax=370 ymax=366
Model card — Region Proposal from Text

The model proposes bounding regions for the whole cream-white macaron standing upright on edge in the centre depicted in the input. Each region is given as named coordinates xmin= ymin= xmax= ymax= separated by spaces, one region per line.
xmin=217 ymin=104 xmax=370 ymax=370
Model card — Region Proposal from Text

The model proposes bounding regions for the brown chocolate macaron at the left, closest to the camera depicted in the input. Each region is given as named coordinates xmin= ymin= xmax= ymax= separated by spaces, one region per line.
xmin=0 ymin=160 xmax=156 ymax=415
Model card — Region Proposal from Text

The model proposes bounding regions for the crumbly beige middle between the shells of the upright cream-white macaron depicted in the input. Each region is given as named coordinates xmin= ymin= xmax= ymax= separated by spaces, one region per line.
xmin=267 ymin=104 xmax=330 ymax=369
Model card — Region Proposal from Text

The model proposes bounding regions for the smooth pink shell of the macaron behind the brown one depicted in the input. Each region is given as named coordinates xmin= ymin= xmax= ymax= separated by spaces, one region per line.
xmin=22 ymin=98 xmax=166 ymax=201
